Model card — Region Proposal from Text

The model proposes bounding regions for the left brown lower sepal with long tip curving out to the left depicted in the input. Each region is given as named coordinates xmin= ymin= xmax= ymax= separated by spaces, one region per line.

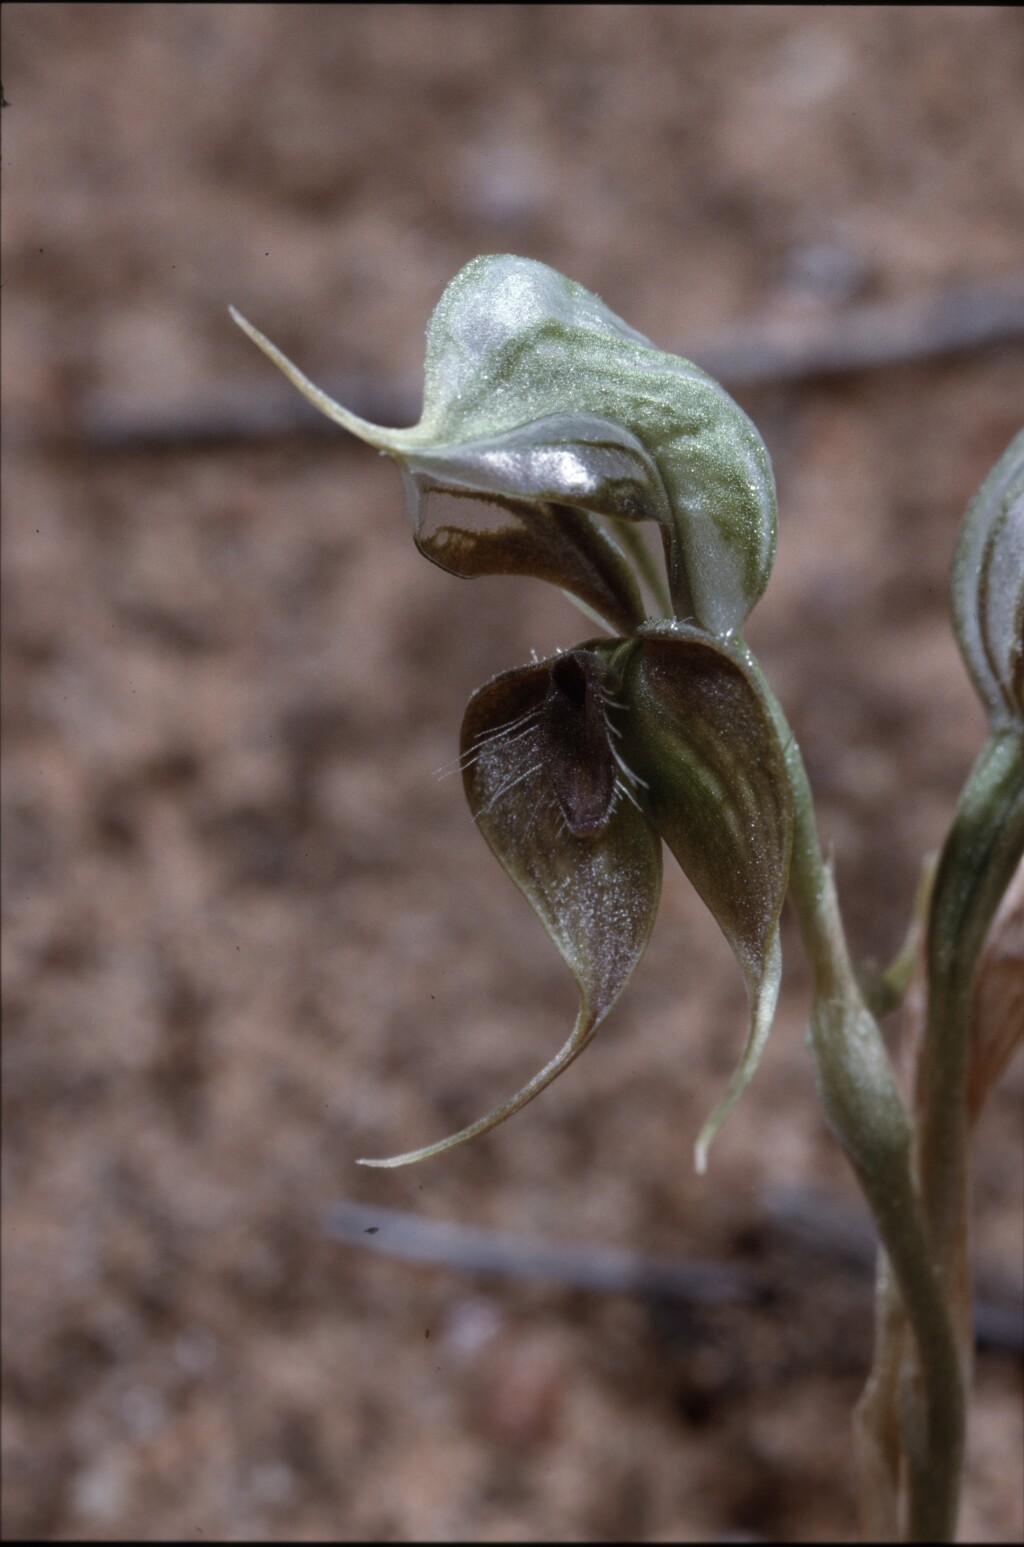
xmin=364 ymin=648 xmax=660 ymax=1166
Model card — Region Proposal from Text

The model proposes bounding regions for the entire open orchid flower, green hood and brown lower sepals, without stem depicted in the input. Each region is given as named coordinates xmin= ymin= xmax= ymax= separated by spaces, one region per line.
xmin=232 ymin=257 xmax=792 ymax=1170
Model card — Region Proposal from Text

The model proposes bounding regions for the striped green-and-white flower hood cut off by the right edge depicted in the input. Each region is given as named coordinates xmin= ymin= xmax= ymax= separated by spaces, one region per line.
xmin=950 ymin=430 xmax=1024 ymax=729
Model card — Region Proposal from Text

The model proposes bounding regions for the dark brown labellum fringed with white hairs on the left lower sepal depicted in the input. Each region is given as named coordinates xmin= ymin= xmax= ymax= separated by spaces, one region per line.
xmin=540 ymin=650 xmax=616 ymax=838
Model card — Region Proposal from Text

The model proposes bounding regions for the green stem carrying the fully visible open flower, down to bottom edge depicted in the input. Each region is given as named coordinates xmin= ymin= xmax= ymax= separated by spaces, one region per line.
xmin=746 ymin=651 xmax=964 ymax=1541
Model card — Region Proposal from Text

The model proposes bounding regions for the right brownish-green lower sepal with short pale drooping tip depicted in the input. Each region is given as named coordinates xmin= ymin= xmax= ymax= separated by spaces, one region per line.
xmin=620 ymin=625 xmax=792 ymax=1171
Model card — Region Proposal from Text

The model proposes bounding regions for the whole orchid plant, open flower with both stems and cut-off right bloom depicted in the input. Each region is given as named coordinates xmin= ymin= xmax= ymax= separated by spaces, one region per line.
xmin=234 ymin=257 xmax=1024 ymax=1541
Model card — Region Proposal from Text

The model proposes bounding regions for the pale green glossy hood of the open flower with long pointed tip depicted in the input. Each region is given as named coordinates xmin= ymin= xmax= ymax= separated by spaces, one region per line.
xmin=234 ymin=255 xmax=777 ymax=636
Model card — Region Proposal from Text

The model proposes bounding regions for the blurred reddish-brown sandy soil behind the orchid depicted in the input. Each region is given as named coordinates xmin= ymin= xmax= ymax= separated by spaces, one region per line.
xmin=0 ymin=5 xmax=1024 ymax=1542
